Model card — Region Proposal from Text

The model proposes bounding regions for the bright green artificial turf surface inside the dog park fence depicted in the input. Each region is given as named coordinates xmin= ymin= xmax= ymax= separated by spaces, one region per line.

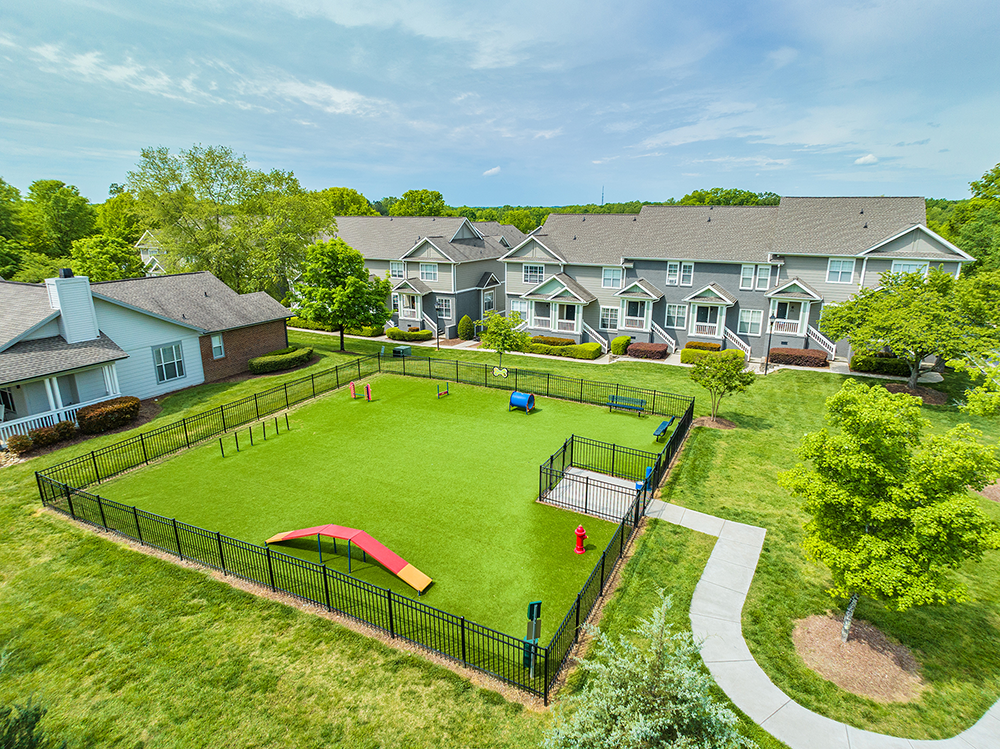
xmin=101 ymin=375 xmax=659 ymax=641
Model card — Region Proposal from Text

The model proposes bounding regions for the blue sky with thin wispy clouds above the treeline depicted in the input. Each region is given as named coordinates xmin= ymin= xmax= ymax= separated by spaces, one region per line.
xmin=0 ymin=0 xmax=1000 ymax=205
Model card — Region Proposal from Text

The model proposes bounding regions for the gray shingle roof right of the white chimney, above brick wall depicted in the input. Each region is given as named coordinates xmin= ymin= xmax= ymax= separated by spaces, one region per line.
xmin=90 ymin=271 xmax=293 ymax=333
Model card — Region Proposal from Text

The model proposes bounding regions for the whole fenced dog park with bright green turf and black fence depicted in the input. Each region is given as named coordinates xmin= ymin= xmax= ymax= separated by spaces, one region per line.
xmin=37 ymin=355 xmax=693 ymax=698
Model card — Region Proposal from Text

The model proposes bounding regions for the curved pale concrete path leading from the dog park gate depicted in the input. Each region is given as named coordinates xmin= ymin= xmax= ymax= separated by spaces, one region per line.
xmin=646 ymin=500 xmax=1000 ymax=749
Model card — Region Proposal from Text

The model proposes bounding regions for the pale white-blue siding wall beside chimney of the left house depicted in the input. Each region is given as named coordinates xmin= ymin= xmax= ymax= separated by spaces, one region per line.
xmin=94 ymin=299 xmax=205 ymax=398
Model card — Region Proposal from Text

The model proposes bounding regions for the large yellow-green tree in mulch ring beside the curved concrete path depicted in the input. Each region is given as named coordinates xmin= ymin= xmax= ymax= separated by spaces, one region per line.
xmin=778 ymin=380 xmax=1000 ymax=642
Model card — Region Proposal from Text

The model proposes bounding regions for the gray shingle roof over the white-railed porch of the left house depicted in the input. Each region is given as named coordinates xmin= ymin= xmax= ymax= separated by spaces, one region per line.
xmin=0 ymin=333 xmax=128 ymax=384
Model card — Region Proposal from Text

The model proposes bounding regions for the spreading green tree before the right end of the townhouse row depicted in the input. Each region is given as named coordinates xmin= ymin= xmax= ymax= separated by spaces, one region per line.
xmin=819 ymin=268 xmax=970 ymax=390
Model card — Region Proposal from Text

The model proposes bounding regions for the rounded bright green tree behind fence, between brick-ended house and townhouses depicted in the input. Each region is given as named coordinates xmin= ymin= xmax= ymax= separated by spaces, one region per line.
xmin=294 ymin=239 xmax=392 ymax=351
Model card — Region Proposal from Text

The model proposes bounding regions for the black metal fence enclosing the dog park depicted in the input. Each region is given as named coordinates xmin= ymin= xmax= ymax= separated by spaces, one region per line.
xmin=35 ymin=354 xmax=694 ymax=703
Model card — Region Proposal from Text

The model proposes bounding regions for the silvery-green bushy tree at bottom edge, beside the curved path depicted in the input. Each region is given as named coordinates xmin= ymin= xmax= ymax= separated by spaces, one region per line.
xmin=542 ymin=591 xmax=754 ymax=749
